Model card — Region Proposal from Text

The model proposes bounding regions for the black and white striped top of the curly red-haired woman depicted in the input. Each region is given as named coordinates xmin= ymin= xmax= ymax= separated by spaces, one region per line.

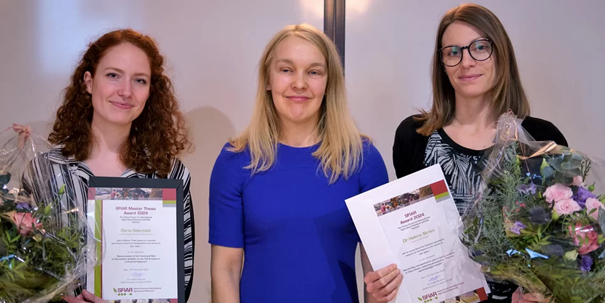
xmin=23 ymin=147 xmax=195 ymax=299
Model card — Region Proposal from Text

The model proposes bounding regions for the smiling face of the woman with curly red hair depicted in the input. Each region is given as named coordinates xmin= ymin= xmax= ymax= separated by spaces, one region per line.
xmin=84 ymin=43 xmax=151 ymax=126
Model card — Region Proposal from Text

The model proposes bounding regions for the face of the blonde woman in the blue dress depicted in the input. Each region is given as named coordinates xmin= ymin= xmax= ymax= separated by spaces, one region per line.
xmin=267 ymin=36 xmax=328 ymax=128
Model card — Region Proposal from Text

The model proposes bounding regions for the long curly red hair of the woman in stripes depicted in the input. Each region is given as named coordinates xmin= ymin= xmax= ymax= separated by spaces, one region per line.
xmin=48 ymin=29 xmax=192 ymax=177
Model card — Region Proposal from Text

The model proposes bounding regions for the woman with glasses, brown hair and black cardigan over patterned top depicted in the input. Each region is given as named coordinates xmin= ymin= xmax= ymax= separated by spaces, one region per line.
xmin=393 ymin=4 xmax=567 ymax=302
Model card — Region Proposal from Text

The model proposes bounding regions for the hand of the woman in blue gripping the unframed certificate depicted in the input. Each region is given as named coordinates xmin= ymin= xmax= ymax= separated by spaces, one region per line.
xmin=364 ymin=264 xmax=403 ymax=303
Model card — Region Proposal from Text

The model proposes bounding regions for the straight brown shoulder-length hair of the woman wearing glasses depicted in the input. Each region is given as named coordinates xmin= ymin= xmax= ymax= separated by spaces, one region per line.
xmin=417 ymin=4 xmax=530 ymax=136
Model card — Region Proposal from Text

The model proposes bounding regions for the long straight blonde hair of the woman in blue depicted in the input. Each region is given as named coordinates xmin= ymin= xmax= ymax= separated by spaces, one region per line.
xmin=230 ymin=24 xmax=369 ymax=183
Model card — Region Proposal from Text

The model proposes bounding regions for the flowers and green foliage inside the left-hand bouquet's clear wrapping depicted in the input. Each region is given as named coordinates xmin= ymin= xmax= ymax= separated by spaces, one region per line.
xmin=0 ymin=175 xmax=85 ymax=303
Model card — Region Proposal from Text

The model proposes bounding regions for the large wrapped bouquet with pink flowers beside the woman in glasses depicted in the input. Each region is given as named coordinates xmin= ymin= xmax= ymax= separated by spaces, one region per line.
xmin=461 ymin=113 xmax=605 ymax=303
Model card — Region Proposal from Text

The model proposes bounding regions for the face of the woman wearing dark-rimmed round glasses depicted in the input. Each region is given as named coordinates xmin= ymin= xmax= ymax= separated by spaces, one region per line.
xmin=441 ymin=22 xmax=496 ymax=99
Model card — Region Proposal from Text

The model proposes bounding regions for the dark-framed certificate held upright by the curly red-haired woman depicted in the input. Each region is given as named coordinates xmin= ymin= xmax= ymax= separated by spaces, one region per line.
xmin=86 ymin=178 xmax=185 ymax=303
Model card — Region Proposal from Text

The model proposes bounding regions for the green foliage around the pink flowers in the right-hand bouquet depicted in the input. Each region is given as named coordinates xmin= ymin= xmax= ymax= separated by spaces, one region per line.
xmin=462 ymin=142 xmax=605 ymax=303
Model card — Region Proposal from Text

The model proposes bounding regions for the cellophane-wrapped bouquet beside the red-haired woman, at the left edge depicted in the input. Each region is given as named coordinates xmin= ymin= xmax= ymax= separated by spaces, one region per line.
xmin=0 ymin=125 xmax=100 ymax=303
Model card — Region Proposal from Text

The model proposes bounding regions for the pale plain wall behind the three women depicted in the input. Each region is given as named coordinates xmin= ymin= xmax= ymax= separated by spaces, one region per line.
xmin=0 ymin=0 xmax=605 ymax=303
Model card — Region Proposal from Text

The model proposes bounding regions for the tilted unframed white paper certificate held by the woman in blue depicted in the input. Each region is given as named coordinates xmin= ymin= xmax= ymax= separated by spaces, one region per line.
xmin=346 ymin=165 xmax=489 ymax=303
